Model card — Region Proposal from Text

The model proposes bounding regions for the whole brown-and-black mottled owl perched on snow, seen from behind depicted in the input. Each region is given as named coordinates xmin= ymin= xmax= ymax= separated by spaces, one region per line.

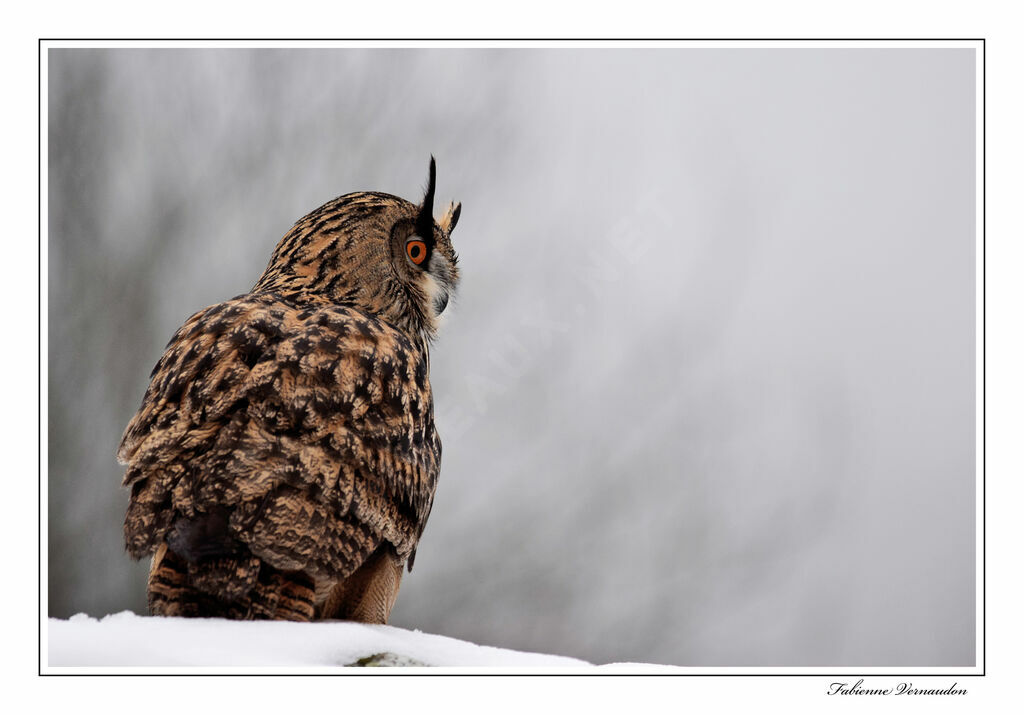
xmin=118 ymin=157 xmax=462 ymax=623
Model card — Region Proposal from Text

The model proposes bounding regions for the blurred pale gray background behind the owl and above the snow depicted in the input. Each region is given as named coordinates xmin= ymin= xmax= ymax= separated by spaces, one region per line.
xmin=47 ymin=48 xmax=976 ymax=666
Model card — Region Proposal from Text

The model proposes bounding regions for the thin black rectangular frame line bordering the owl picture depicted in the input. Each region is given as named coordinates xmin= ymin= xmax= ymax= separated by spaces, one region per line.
xmin=36 ymin=37 xmax=988 ymax=678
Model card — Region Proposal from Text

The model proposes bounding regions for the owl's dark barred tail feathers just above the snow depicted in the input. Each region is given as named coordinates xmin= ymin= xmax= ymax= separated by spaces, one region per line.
xmin=147 ymin=544 xmax=314 ymax=621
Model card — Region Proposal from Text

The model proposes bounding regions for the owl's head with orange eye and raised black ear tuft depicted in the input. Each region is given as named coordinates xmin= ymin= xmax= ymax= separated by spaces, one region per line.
xmin=253 ymin=157 xmax=462 ymax=339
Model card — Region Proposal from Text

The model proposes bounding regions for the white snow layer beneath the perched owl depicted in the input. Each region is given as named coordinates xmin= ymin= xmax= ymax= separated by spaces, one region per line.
xmin=47 ymin=611 xmax=591 ymax=669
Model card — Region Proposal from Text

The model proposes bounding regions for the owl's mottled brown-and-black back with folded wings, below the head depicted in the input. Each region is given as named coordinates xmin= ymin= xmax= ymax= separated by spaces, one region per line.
xmin=118 ymin=295 xmax=440 ymax=579
